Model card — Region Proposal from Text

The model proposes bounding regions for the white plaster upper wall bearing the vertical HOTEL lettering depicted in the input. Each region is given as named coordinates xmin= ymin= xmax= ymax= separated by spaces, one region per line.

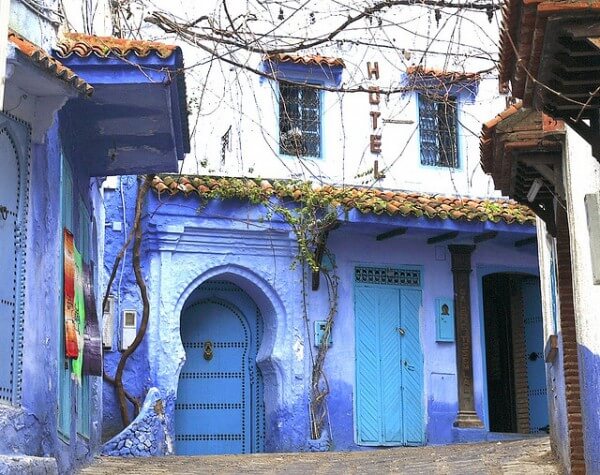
xmin=57 ymin=0 xmax=506 ymax=196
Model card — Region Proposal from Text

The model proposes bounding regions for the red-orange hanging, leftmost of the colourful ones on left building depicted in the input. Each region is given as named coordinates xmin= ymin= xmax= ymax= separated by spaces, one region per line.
xmin=63 ymin=229 xmax=79 ymax=358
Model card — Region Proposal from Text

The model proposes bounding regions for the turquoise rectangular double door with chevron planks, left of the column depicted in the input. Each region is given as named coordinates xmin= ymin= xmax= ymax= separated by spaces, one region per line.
xmin=355 ymin=285 xmax=423 ymax=445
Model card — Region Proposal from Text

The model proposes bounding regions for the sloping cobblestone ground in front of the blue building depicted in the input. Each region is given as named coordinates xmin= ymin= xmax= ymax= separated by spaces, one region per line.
xmin=80 ymin=437 xmax=561 ymax=475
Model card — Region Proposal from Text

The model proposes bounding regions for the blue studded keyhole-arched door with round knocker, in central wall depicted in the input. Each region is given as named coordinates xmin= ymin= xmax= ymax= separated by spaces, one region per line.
xmin=175 ymin=280 xmax=264 ymax=455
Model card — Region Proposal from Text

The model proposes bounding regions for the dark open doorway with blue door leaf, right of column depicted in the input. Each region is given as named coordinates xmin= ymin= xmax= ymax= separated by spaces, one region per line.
xmin=483 ymin=273 xmax=548 ymax=433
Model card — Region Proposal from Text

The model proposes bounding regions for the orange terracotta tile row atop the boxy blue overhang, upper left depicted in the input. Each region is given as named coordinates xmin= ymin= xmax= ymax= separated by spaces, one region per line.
xmin=56 ymin=33 xmax=178 ymax=58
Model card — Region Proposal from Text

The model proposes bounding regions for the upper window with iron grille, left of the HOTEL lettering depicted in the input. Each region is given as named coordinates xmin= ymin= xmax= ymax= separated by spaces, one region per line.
xmin=279 ymin=84 xmax=321 ymax=157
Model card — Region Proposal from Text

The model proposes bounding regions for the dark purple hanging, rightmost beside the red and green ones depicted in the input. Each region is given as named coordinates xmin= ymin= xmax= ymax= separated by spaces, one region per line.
xmin=83 ymin=264 xmax=102 ymax=376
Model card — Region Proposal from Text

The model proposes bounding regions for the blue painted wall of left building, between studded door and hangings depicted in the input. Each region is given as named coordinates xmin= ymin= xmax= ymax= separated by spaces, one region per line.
xmin=0 ymin=123 xmax=102 ymax=473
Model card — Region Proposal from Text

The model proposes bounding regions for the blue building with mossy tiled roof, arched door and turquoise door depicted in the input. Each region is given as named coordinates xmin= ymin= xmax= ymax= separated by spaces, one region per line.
xmin=104 ymin=175 xmax=548 ymax=454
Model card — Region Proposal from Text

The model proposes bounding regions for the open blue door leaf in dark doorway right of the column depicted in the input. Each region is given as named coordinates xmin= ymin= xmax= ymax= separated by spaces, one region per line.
xmin=522 ymin=278 xmax=549 ymax=433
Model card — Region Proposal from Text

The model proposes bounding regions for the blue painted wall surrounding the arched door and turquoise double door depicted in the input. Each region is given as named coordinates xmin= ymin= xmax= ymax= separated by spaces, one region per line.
xmin=105 ymin=178 xmax=537 ymax=451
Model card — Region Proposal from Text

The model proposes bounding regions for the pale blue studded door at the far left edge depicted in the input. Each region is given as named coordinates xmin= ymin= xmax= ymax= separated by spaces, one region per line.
xmin=0 ymin=113 xmax=29 ymax=403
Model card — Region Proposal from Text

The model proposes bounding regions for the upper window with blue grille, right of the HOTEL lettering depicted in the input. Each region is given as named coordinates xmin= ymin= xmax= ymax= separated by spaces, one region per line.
xmin=419 ymin=95 xmax=459 ymax=168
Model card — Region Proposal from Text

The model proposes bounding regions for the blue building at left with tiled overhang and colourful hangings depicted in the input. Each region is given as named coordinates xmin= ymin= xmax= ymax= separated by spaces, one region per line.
xmin=0 ymin=12 xmax=187 ymax=473
